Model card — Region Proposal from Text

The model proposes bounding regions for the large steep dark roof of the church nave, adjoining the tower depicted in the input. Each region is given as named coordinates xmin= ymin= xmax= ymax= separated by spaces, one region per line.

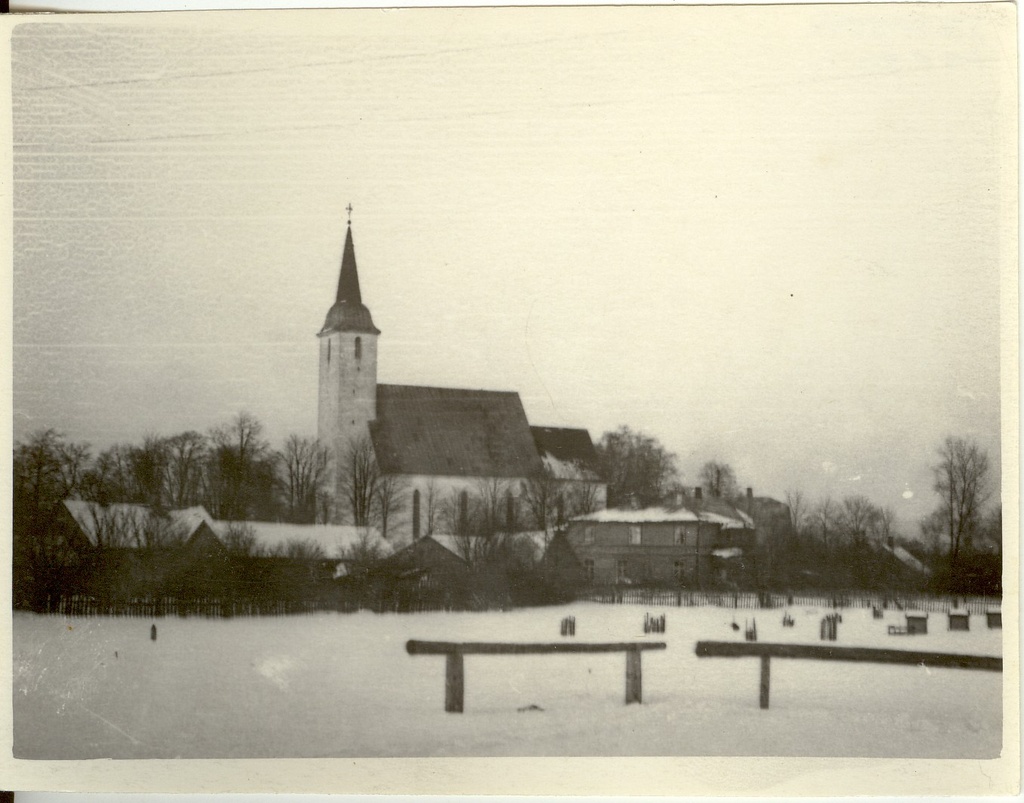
xmin=370 ymin=385 xmax=541 ymax=477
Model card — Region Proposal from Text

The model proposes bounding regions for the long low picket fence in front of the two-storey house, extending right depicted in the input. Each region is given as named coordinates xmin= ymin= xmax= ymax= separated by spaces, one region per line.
xmin=579 ymin=587 xmax=1002 ymax=616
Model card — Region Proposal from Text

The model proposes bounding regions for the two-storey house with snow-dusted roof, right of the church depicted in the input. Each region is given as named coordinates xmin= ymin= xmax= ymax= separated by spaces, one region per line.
xmin=567 ymin=489 xmax=757 ymax=587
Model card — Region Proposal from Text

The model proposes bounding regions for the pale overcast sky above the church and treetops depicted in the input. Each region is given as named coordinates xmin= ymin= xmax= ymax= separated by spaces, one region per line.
xmin=11 ymin=4 xmax=1017 ymax=535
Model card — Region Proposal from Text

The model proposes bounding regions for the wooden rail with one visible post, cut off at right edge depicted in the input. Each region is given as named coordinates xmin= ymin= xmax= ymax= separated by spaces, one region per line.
xmin=696 ymin=641 xmax=1002 ymax=709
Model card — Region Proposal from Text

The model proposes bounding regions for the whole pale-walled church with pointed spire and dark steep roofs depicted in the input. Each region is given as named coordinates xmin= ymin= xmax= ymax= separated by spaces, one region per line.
xmin=316 ymin=219 xmax=607 ymax=540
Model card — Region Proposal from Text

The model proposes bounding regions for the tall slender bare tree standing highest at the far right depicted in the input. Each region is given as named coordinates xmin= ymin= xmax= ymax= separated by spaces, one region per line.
xmin=932 ymin=436 xmax=989 ymax=567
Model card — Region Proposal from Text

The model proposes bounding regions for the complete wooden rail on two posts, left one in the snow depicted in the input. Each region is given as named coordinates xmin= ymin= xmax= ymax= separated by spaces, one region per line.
xmin=406 ymin=639 xmax=665 ymax=713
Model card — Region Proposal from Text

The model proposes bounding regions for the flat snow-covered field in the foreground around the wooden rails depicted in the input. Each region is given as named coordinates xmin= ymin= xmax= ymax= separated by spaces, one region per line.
xmin=13 ymin=603 xmax=1001 ymax=759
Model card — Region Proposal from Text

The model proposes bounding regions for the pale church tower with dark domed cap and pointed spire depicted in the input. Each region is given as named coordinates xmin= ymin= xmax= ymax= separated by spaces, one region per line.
xmin=316 ymin=213 xmax=380 ymax=514
